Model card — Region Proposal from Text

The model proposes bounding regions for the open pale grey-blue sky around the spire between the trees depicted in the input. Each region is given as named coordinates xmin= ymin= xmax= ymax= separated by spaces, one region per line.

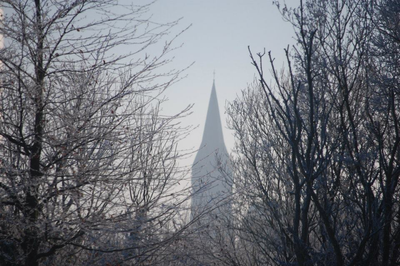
xmin=144 ymin=0 xmax=299 ymax=168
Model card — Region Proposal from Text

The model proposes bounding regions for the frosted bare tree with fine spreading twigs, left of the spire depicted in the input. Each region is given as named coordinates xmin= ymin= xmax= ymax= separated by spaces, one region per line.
xmin=0 ymin=0 xmax=192 ymax=265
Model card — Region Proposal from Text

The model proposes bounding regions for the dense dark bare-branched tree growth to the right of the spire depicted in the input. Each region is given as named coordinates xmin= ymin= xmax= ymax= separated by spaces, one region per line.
xmin=229 ymin=0 xmax=400 ymax=265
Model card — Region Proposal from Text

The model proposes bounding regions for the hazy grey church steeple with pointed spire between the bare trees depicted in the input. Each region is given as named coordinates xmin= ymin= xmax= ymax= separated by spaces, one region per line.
xmin=191 ymin=78 xmax=232 ymax=218
